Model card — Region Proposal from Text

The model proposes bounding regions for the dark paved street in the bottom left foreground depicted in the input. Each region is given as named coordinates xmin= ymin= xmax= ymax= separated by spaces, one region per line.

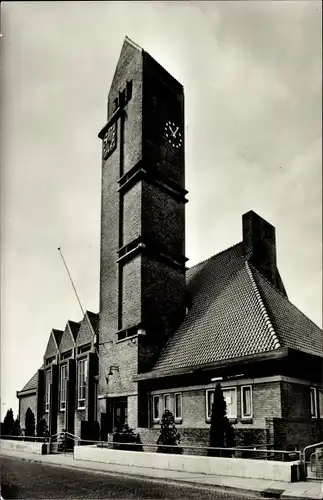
xmin=0 ymin=457 xmax=256 ymax=500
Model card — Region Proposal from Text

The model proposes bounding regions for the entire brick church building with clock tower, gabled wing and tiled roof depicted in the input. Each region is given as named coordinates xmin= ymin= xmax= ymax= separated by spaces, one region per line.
xmin=17 ymin=37 xmax=323 ymax=449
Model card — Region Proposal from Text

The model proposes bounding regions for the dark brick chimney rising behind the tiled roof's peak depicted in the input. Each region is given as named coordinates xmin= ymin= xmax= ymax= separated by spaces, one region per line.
xmin=242 ymin=210 xmax=278 ymax=286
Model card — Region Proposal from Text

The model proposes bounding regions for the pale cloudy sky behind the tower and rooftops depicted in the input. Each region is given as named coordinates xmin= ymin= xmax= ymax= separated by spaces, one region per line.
xmin=0 ymin=0 xmax=322 ymax=419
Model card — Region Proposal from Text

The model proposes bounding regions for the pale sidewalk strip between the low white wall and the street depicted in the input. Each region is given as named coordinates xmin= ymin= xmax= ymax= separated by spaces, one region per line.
xmin=1 ymin=450 xmax=323 ymax=500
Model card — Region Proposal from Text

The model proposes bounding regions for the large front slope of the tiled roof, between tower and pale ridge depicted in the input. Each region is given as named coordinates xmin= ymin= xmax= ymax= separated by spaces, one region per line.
xmin=154 ymin=243 xmax=276 ymax=371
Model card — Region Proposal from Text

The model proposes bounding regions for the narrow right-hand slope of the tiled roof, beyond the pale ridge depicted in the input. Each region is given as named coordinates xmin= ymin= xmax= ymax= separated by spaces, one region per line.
xmin=252 ymin=268 xmax=323 ymax=357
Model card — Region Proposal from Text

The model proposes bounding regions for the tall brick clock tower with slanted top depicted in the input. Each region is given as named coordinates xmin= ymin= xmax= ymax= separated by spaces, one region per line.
xmin=98 ymin=38 xmax=187 ymax=432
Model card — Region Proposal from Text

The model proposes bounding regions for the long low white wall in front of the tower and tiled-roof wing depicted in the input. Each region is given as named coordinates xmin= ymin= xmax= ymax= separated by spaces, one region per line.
xmin=74 ymin=446 xmax=299 ymax=482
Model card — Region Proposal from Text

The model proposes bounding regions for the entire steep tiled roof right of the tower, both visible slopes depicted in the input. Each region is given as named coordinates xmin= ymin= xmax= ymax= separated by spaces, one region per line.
xmin=153 ymin=243 xmax=323 ymax=372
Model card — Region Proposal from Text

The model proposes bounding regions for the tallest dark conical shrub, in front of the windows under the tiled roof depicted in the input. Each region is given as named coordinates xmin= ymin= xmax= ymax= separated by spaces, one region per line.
xmin=208 ymin=384 xmax=235 ymax=456
